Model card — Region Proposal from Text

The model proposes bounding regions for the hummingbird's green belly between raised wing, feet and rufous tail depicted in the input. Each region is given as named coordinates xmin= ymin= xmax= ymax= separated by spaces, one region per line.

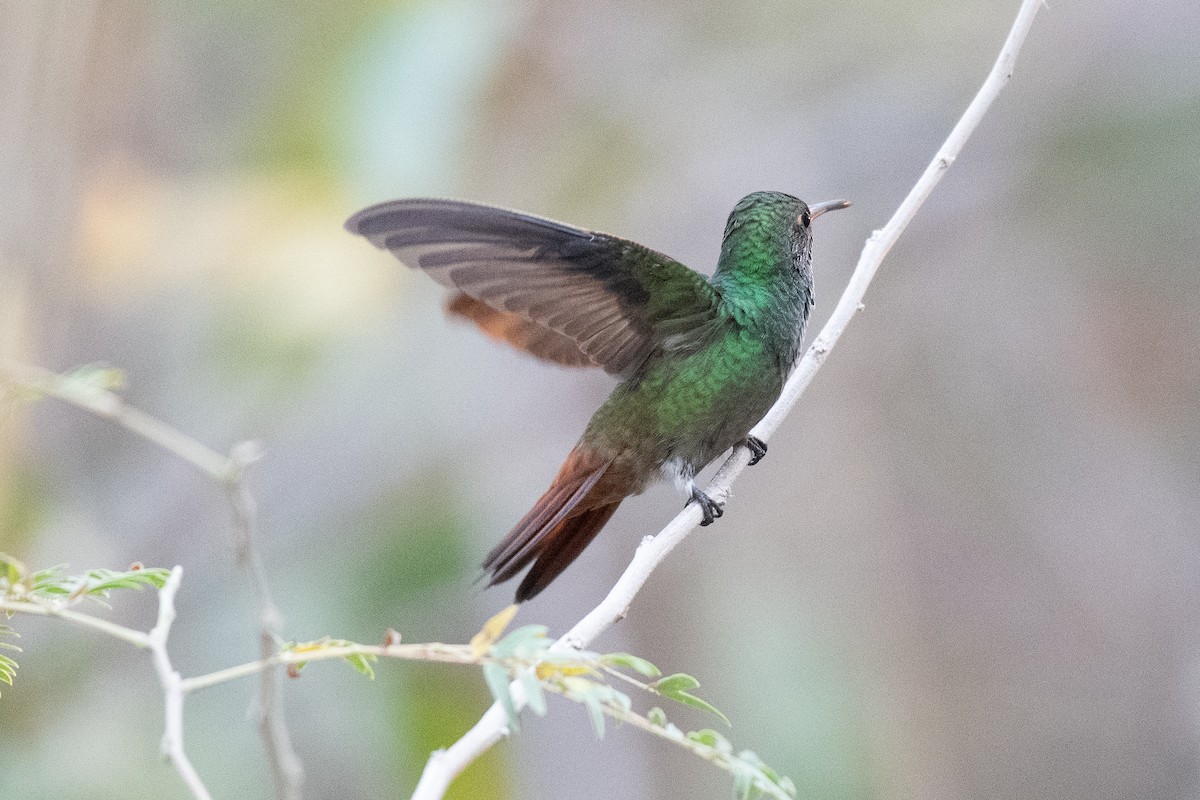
xmin=583 ymin=331 xmax=785 ymax=488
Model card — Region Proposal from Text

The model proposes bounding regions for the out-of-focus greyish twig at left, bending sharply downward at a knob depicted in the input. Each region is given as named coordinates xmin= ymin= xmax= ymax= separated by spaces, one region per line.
xmin=0 ymin=359 xmax=304 ymax=800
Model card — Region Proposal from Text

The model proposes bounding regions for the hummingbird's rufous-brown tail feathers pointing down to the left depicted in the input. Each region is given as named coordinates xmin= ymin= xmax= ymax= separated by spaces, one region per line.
xmin=484 ymin=447 xmax=626 ymax=602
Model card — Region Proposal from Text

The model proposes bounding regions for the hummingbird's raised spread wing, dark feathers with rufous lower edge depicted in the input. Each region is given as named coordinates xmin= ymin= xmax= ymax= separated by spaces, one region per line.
xmin=346 ymin=199 xmax=720 ymax=377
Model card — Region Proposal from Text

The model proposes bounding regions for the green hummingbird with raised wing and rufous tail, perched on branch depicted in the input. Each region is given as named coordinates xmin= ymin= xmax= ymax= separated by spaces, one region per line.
xmin=346 ymin=192 xmax=850 ymax=603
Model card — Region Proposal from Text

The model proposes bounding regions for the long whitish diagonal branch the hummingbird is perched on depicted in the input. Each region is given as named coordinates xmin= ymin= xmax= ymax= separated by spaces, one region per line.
xmin=413 ymin=0 xmax=1042 ymax=800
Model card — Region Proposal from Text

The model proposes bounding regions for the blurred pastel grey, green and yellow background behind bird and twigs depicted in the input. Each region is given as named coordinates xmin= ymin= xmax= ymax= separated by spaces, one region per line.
xmin=0 ymin=0 xmax=1200 ymax=800
